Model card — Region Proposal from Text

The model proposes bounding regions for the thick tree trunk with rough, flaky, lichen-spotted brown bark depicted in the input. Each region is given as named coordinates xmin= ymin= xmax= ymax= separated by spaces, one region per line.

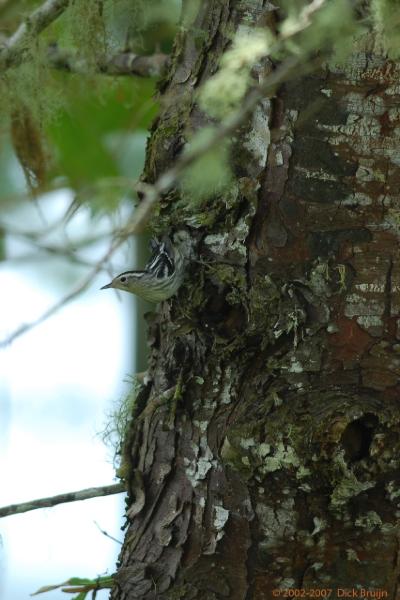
xmin=112 ymin=0 xmax=400 ymax=600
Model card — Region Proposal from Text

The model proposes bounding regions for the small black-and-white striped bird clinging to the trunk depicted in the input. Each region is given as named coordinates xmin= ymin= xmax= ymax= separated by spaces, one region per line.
xmin=101 ymin=234 xmax=185 ymax=302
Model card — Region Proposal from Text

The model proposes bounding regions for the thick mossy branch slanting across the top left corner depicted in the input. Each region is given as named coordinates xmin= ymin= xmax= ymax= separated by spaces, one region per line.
xmin=0 ymin=0 xmax=70 ymax=71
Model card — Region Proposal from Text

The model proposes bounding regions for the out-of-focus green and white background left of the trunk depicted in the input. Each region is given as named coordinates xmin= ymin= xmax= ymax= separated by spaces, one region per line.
xmin=0 ymin=0 xmax=180 ymax=600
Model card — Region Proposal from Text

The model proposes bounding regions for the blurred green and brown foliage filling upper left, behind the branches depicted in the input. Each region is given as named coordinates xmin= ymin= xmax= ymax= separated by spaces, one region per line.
xmin=0 ymin=0 xmax=179 ymax=206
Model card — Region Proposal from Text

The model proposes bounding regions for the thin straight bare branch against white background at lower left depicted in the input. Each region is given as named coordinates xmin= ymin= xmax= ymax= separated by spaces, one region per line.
xmin=0 ymin=483 xmax=126 ymax=519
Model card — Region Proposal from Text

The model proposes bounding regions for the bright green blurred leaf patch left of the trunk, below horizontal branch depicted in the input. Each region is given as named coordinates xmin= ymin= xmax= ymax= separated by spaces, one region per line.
xmin=48 ymin=75 xmax=158 ymax=188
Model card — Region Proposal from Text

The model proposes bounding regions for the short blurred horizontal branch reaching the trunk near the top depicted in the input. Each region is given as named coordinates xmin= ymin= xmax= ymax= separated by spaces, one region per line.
xmin=48 ymin=44 xmax=169 ymax=77
